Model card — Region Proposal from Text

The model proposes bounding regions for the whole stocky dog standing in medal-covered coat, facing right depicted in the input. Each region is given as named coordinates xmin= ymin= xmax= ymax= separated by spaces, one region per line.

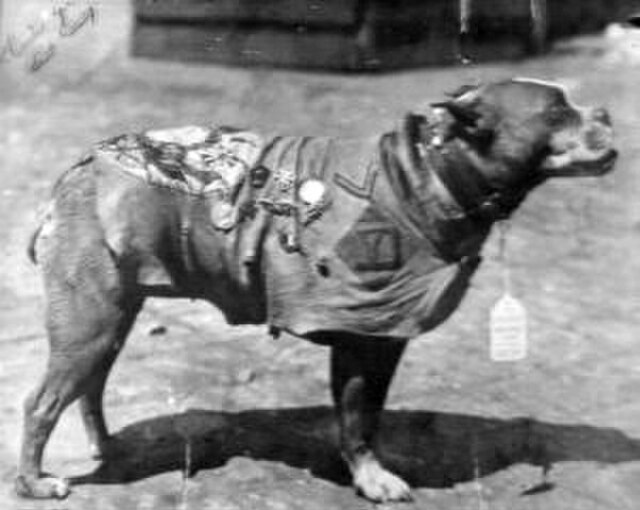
xmin=15 ymin=79 xmax=617 ymax=502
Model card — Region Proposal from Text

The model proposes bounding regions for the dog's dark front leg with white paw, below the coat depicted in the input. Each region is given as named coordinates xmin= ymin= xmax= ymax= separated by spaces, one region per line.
xmin=331 ymin=335 xmax=411 ymax=502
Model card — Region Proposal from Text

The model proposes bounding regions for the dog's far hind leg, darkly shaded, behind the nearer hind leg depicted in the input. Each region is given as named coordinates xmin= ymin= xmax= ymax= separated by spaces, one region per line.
xmin=79 ymin=302 xmax=142 ymax=459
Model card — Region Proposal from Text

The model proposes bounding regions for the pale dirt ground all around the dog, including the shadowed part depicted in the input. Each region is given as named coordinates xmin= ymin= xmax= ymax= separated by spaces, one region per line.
xmin=0 ymin=0 xmax=640 ymax=510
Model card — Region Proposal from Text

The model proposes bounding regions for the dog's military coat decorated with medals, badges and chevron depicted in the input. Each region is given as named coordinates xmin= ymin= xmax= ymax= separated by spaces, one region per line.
xmin=87 ymin=119 xmax=480 ymax=337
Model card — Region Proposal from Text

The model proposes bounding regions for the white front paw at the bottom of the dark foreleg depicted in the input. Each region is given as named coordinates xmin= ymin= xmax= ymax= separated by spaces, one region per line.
xmin=353 ymin=459 xmax=412 ymax=503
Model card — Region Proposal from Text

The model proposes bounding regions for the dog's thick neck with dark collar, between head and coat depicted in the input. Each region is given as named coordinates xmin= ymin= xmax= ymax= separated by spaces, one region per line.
xmin=381 ymin=115 xmax=535 ymax=261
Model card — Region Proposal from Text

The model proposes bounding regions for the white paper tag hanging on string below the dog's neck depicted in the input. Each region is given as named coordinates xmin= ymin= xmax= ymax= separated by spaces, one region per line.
xmin=489 ymin=293 xmax=527 ymax=361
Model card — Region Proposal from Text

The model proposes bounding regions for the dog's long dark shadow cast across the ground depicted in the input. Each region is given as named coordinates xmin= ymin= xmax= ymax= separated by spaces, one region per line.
xmin=72 ymin=407 xmax=640 ymax=491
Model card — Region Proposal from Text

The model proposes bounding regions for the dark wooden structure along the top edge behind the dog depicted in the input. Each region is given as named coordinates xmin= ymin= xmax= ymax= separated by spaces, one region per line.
xmin=132 ymin=0 xmax=628 ymax=71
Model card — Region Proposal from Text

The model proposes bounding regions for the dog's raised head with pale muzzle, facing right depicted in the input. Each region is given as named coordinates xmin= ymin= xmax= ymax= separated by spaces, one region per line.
xmin=433 ymin=79 xmax=617 ymax=180
